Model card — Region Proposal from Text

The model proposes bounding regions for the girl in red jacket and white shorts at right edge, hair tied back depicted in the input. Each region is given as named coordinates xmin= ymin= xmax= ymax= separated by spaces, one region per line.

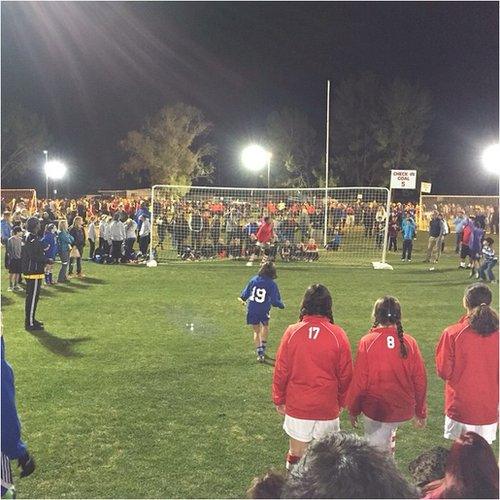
xmin=436 ymin=283 xmax=498 ymax=444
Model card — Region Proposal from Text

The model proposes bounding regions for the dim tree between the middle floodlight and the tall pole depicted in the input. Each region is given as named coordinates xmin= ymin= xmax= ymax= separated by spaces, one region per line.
xmin=267 ymin=108 xmax=321 ymax=187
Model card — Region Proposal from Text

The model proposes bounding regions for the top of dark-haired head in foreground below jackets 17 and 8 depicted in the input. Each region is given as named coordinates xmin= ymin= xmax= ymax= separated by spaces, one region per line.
xmin=281 ymin=432 xmax=420 ymax=498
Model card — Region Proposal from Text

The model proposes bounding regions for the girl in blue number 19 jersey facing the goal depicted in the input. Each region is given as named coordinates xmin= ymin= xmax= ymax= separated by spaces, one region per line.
xmin=239 ymin=262 xmax=285 ymax=362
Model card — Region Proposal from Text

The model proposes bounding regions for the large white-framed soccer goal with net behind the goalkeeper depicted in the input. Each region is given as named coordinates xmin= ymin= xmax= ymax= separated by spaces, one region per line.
xmin=150 ymin=186 xmax=389 ymax=264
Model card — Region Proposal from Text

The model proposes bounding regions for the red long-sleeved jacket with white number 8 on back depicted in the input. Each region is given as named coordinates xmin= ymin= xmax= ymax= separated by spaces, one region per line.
xmin=346 ymin=326 xmax=427 ymax=422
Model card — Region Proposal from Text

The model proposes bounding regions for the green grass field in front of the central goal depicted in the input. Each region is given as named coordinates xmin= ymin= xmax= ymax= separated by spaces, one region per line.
xmin=2 ymin=240 xmax=498 ymax=498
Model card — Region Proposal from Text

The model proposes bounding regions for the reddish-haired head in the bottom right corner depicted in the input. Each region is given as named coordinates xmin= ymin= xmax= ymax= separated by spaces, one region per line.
xmin=424 ymin=432 xmax=498 ymax=498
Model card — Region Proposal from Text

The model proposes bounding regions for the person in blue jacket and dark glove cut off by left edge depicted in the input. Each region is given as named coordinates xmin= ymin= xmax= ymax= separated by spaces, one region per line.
xmin=0 ymin=335 xmax=35 ymax=498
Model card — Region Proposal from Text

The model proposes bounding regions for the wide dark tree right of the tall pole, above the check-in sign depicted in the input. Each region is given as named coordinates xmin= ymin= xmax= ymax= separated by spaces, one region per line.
xmin=332 ymin=72 xmax=431 ymax=186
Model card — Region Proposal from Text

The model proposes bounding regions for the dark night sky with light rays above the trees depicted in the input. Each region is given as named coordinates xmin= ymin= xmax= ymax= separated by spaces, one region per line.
xmin=1 ymin=2 xmax=499 ymax=194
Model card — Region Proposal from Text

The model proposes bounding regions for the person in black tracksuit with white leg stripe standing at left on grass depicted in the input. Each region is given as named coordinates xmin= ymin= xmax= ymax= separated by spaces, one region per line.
xmin=21 ymin=217 xmax=53 ymax=331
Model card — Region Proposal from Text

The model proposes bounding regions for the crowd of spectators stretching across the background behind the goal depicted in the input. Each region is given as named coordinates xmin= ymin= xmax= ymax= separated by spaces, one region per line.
xmin=2 ymin=194 xmax=498 ymax=268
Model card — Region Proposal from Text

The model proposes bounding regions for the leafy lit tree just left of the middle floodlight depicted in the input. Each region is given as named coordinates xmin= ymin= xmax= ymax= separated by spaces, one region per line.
xmin=120 ymin=103 xmax=215 ymax=185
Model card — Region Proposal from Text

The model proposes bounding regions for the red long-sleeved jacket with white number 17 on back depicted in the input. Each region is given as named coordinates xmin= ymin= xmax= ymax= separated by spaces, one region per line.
xmin=272 ymin=316 xmax=352 ymax=420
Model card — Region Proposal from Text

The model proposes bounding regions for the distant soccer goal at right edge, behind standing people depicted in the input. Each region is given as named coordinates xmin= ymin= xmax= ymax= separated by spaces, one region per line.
xmin=418 ymin=194 xmax=500 ymax=232
